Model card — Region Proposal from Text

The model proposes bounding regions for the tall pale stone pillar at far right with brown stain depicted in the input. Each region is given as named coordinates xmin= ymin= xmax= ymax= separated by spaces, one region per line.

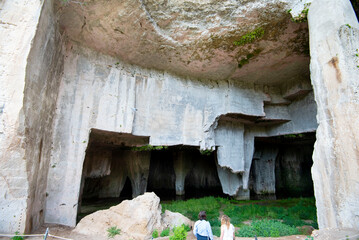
xmin=308 ymin=0 xmax=359 ymax=229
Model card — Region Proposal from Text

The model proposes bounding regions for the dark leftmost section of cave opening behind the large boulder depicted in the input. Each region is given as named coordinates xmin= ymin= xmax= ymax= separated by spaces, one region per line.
xmin=77 ymin=129 xmax=150 ymax=221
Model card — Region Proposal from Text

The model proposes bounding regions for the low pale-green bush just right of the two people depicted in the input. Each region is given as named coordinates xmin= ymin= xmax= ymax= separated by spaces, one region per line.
xmin=236 ymin=219 xmax=299 ymax=237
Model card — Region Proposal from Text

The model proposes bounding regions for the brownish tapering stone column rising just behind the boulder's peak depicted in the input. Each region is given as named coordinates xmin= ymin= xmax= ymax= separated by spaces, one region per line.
xmin=124 ymin=151 xmax=151 ymax=198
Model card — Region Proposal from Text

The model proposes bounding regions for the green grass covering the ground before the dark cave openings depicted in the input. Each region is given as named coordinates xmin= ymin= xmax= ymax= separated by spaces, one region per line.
xmin=162 ymin=197 xmax=318 ymax=237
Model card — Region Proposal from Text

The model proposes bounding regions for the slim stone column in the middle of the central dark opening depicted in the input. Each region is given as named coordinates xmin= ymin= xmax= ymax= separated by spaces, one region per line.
xmin=173 ymin=151 xmax=191 ymax=195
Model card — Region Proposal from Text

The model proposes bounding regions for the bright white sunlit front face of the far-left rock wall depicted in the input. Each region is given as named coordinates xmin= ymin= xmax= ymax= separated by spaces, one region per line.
xmin=0 ymin=0 xmax=48 ymax=232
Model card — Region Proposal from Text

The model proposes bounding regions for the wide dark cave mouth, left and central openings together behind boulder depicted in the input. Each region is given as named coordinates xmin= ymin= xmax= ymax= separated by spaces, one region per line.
xmin=77 ymin=129 xmax=227 ymax=221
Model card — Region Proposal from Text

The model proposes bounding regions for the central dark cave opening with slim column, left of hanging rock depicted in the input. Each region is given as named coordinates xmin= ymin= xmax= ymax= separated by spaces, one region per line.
xmin=147 ymin=145 xmax=224 ymax=201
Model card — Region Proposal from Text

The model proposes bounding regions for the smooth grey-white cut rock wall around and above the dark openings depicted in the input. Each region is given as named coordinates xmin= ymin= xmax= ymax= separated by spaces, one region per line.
xmin=42 ymin=43 xmax=316 ymax=226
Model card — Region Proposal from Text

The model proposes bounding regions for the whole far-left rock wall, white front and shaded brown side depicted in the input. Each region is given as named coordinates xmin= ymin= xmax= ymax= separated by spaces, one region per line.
xmin=0 ymin=1 xmax=62 ymax=233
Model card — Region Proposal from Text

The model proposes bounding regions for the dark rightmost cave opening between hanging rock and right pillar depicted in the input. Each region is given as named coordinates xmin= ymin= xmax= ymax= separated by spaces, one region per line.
xmin=250 ymin=133 xmax=316 ymax=199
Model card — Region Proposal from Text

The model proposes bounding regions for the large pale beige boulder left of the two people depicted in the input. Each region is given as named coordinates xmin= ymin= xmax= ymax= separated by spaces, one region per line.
xmin=73 ymin=192 xmax=192 ymax=240
